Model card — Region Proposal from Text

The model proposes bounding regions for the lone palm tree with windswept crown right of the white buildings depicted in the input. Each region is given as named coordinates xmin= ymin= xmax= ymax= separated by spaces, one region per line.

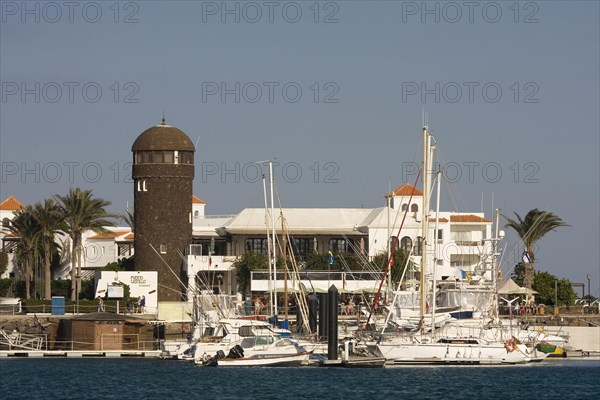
xmin=504 ymin=208 xmax=569 ymax=289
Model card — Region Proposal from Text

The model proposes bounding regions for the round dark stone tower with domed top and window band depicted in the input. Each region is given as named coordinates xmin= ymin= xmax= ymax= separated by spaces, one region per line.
xmin=131 ymin=118 xmax=195 ymax=301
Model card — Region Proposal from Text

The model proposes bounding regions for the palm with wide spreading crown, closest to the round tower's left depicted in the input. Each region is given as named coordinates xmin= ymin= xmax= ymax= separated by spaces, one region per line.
xmin=54 ymin=188 xmax=114 ymax=300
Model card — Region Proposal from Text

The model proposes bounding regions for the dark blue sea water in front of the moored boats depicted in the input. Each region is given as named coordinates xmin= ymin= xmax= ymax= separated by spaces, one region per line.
xmin=0 ymin=358 xmax=600 ymax=400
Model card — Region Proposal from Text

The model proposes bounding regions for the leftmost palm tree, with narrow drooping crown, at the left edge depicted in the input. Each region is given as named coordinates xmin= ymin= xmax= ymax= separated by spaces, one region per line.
xmin=7 ymin=206 xmax=40 ymax=299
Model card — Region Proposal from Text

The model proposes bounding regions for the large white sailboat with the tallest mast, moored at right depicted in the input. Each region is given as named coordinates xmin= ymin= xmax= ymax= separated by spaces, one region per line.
xmin=376 ymin=124 xmax=543 ymax=365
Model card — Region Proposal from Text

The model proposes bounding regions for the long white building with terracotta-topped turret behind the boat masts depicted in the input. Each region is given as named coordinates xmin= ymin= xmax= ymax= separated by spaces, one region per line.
xmin=188 ymin=184 xmax=492 ymax=295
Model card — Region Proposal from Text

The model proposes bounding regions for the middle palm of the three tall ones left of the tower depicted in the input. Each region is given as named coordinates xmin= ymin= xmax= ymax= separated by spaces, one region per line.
xmin=33 ymin=199 xmax=64 ymax=300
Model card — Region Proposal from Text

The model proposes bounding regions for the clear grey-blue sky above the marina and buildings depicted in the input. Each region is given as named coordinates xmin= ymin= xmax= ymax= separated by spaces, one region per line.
xmin=0 ymin=1 xmax=600 ymax=295
